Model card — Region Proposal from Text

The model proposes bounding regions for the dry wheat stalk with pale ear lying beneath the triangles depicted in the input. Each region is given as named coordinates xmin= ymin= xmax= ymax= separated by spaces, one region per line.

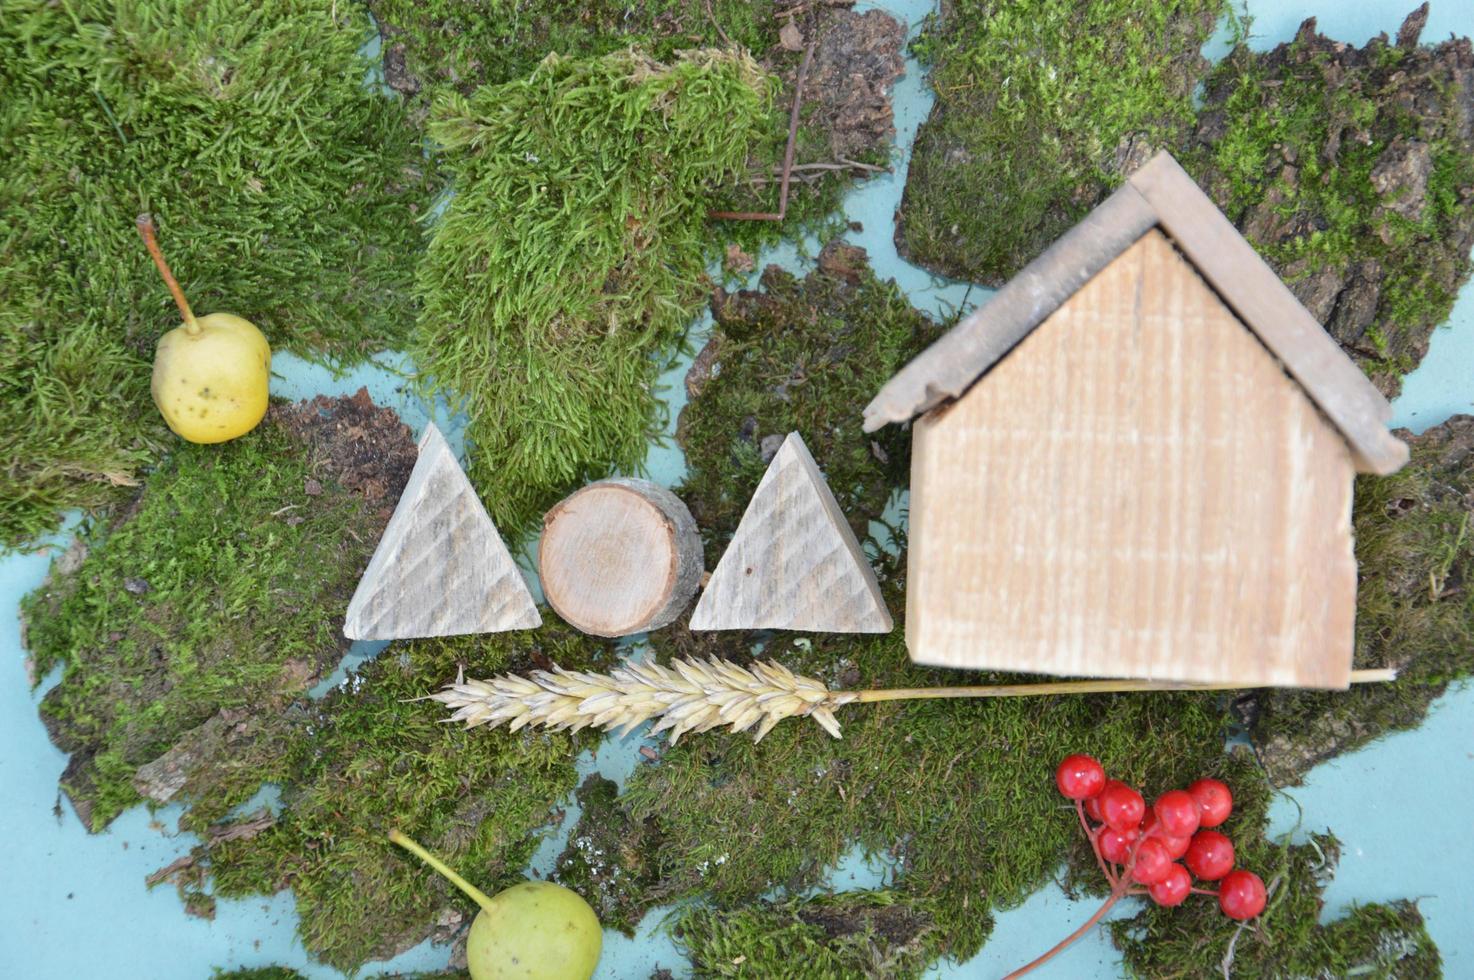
xmin=426 ymin=659 xmax=1397 ymax=746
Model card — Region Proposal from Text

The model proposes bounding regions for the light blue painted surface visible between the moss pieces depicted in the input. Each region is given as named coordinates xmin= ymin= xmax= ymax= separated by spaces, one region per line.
xmin=0 ymin=0 xmax=1474 ymax=980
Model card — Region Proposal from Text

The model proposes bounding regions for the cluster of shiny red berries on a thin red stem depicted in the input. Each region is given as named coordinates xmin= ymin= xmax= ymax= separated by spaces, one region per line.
xmin=1005 ymin=756 xmax=1268 ymax=980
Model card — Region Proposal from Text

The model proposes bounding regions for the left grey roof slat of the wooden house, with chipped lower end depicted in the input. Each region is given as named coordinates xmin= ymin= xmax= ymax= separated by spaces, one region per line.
xmin=865 ymin=184 xmax=1157 ymax=432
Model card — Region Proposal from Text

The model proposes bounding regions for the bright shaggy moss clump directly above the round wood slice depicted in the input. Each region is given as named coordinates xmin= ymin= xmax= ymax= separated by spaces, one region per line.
xmin=413 ymin=50 xmax=771 ymax=535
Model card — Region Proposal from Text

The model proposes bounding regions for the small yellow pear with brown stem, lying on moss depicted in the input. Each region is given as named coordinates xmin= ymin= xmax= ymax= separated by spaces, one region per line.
xmin=139 ymin=214 xmax=271 ymax=442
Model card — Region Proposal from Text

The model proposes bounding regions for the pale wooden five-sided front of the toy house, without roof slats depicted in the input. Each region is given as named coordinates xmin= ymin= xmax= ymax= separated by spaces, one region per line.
xmin=907 ymin=231 xmax=1356 ymax=688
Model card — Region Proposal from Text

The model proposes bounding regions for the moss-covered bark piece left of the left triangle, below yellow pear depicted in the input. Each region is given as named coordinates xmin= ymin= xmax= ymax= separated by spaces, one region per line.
xmin=22 ymin=396 xmax=414 ymax=830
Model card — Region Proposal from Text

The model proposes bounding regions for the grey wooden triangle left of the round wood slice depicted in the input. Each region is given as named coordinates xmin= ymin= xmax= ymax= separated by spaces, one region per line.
xmin=343 ymin=423 xmax=542 ymax=640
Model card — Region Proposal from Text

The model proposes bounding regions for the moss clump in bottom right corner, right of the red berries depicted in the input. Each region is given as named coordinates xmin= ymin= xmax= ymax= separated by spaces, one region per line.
xmin=1108 ymin=748 xmax=1442 ymax=977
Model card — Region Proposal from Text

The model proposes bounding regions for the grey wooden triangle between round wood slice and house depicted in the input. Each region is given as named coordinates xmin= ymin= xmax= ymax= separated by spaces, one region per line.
xmin=691 ymin=432 xmax=892 ymax=632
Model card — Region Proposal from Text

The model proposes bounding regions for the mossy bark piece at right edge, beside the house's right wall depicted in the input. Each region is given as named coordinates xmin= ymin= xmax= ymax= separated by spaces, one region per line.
xmin=1251 ymin=416 xmax=1474 ymax=784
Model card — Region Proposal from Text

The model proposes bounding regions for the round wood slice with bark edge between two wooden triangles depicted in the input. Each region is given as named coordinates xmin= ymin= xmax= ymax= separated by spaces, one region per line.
xmin=538 ymin=477 xmax=702 ymax=637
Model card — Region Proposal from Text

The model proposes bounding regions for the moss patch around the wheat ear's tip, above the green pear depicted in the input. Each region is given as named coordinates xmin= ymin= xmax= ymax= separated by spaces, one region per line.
xmin=184 ymin=613 xmax=613 ymax=970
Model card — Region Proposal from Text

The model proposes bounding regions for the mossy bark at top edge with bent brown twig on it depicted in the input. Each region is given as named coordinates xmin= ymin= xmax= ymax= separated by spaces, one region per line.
xmin=369 ymin=0 xmax=884 ymax=275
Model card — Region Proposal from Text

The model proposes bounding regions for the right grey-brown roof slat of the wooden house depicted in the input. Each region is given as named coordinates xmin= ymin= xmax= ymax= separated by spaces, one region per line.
xmin=1129 ymin=153 xmax=1408 ymax=475
